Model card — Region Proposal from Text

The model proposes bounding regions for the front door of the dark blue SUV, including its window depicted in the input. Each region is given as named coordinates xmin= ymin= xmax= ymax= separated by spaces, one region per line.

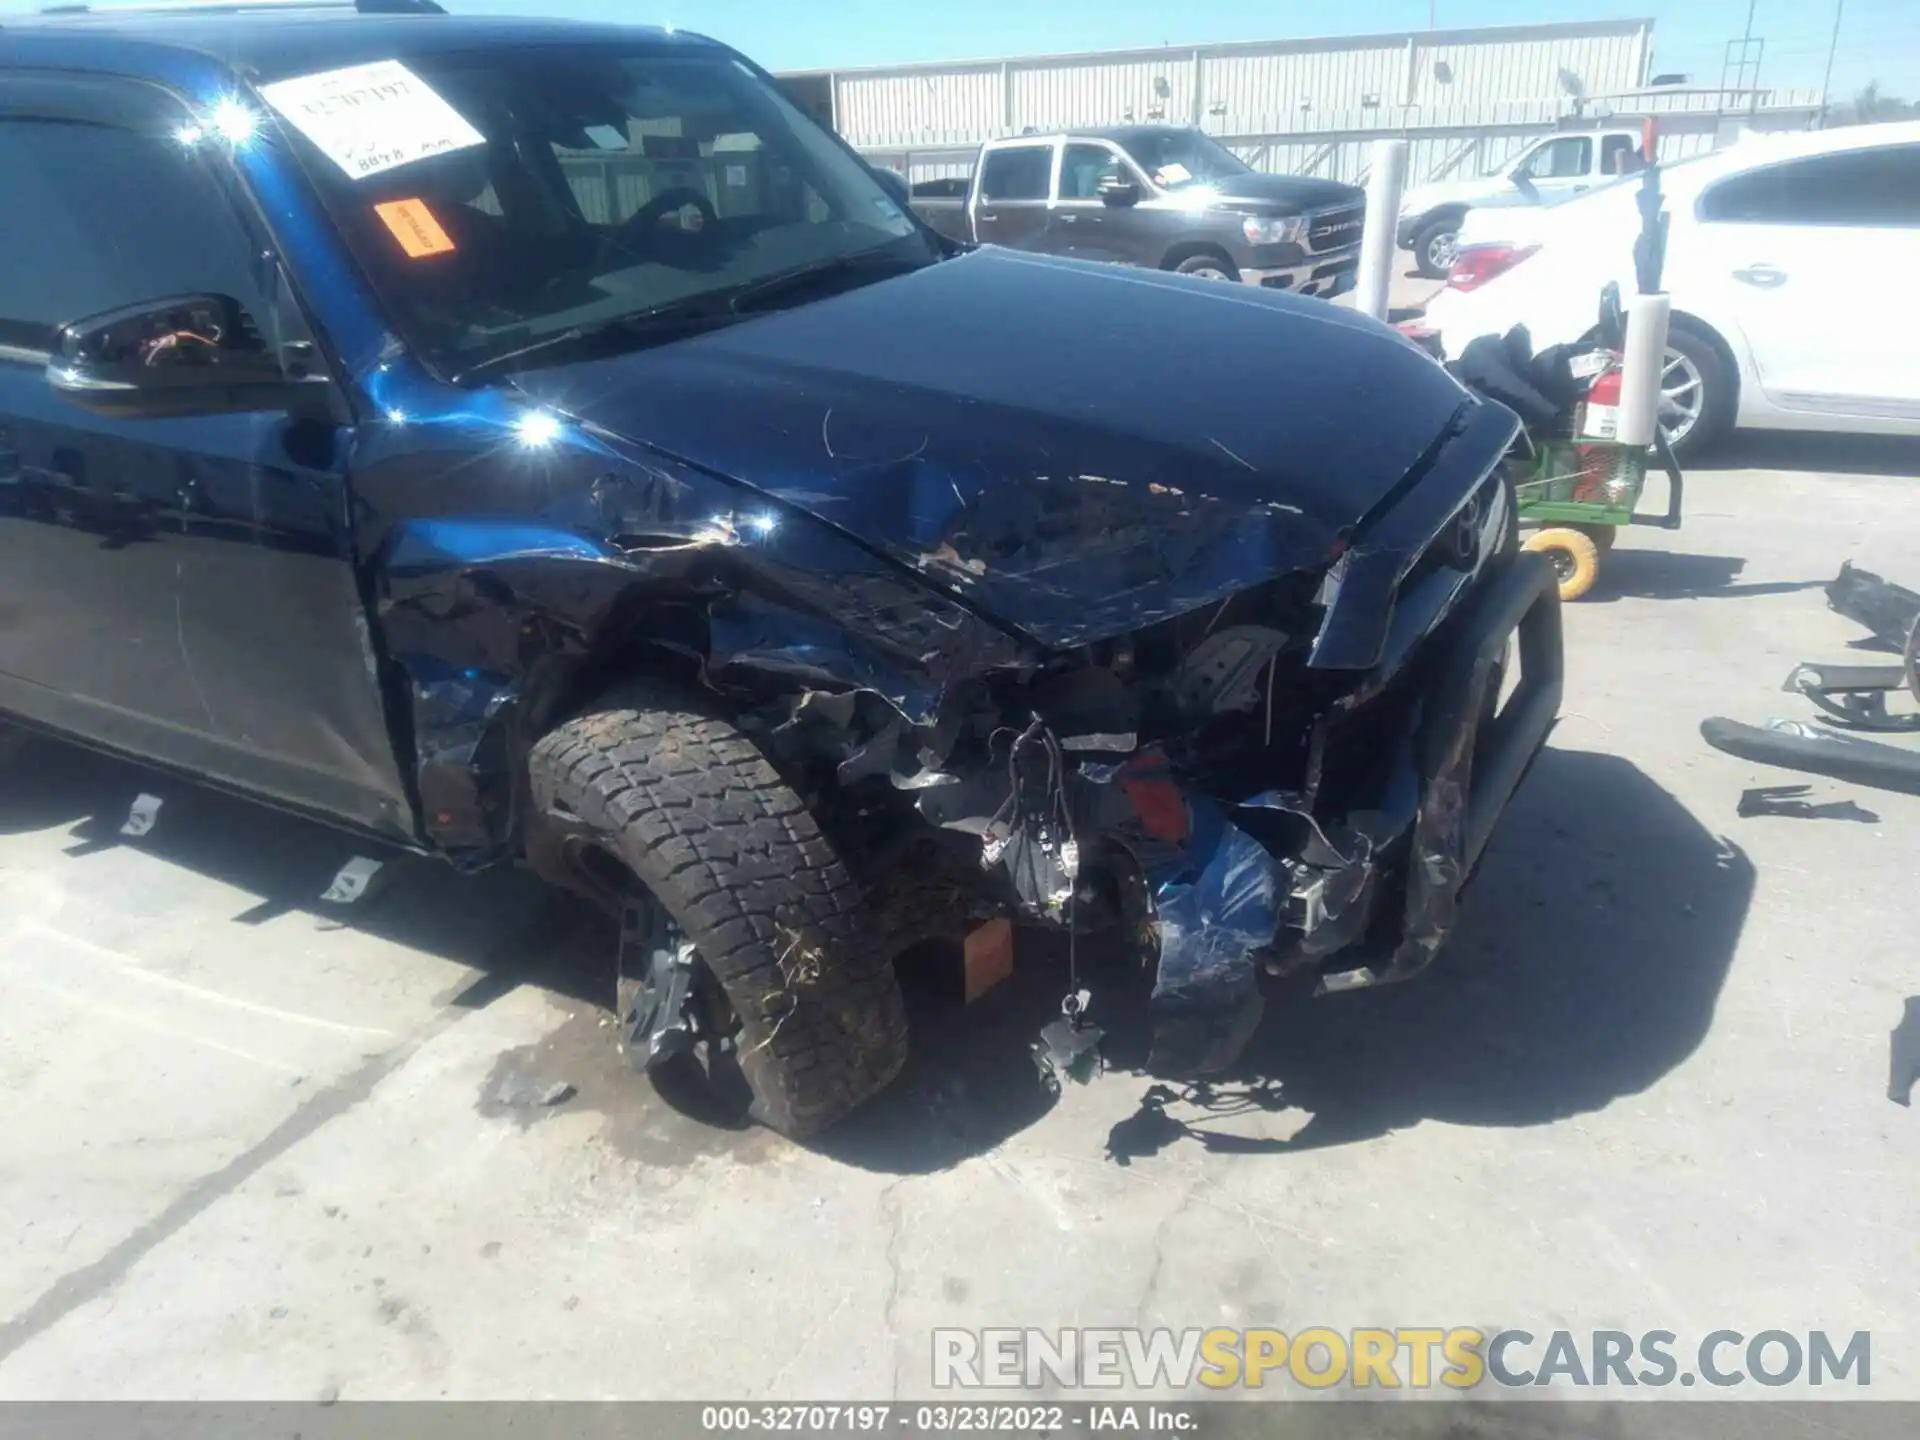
xmin=0 ymin=75 xmax=411 ymax=833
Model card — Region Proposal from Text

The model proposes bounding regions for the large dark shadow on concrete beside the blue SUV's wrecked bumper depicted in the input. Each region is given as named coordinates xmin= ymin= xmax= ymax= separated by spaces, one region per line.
xmin=1112 ymin=749 xmax=1753 ymax=1160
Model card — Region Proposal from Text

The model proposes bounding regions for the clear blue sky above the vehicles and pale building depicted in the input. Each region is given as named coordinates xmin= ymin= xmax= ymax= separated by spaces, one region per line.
xmin=0 ymin=0 xmax=1920 ymax=100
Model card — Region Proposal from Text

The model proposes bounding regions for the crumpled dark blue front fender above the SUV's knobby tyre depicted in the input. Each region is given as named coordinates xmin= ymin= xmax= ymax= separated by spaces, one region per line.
xmin=353 ymin=396 xmax=1023 ymax=864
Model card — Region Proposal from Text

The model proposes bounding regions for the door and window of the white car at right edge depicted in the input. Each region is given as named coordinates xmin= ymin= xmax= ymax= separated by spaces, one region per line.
xmin=1697 ymin=144 xmax=1920 ymax=420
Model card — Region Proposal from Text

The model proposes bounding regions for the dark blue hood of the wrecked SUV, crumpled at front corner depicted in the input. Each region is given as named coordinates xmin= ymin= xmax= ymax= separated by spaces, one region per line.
xmin=516 ymin=250 xmax=1475 ymax=645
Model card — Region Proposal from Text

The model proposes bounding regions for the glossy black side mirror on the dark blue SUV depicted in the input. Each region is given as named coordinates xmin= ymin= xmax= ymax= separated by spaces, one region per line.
xmin=46 ymin=296 xmax=328 ymax=420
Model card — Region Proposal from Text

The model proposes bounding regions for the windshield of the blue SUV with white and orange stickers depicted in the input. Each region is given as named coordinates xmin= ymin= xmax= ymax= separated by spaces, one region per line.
xmin=280 ymin=46 xmax=943 ymax=376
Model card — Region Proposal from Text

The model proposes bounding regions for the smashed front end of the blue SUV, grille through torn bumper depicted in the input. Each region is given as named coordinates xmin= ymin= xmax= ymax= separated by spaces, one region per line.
xmin=687 ymin=397 xmax=1561 ymax=1077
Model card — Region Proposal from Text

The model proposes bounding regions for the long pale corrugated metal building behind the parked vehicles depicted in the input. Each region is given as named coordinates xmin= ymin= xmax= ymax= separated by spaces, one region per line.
xmin=781 ymin=19 xmax=1818 ymax=180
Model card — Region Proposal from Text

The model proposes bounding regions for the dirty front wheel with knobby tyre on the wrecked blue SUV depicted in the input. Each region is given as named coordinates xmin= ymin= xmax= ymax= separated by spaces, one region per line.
xmin=528 ymin=682 xmax=906 ymax=1137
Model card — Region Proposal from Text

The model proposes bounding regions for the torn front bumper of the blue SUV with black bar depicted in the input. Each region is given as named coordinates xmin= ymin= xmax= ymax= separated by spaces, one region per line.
xmin=936 ymin=555 xmax=1563 ymax=1077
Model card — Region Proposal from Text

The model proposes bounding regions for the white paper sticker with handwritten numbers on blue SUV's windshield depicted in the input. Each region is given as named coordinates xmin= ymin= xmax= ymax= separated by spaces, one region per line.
xmin=259 ymin=60 xmax=486 ymax=180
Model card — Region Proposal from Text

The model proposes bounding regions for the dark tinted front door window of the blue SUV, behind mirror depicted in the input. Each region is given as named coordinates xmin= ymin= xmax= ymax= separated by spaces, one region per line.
xmin=0 ymin=119 xmax=271 ymax=353
